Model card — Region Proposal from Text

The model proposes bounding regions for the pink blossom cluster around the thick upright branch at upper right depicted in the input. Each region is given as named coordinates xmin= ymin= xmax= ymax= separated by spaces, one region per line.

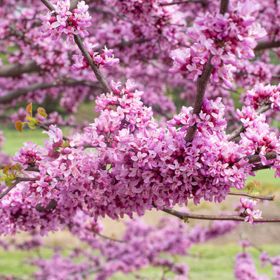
xmin=171 ymin=1 xmax=266 ymax=87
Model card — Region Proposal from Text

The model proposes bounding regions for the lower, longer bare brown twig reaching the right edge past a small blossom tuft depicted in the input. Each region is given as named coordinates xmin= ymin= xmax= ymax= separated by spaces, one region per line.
xmin=162 ymin=209 xmax=280 ymax=223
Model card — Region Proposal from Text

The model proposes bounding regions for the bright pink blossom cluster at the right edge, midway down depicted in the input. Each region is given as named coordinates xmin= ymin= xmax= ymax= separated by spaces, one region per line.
xmin=234 ymin=84 xmax=280 ymax=170
